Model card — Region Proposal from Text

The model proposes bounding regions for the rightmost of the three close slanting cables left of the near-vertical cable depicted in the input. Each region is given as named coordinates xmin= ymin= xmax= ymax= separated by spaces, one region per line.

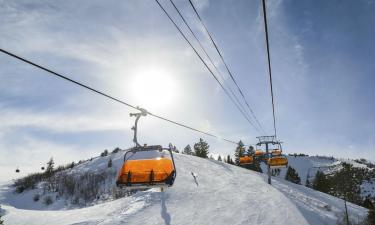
xmin=189 ymin=0 xmax=266 ymax=133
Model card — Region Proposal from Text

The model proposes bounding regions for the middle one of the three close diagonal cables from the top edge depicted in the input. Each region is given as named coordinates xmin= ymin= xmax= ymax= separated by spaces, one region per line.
xmin=169 ymin=0 xmax=260 ymax=132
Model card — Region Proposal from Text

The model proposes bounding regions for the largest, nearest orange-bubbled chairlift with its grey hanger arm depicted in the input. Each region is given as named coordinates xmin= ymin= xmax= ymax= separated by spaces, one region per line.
xmin=116 ymin=108 xmax=176 ymax=189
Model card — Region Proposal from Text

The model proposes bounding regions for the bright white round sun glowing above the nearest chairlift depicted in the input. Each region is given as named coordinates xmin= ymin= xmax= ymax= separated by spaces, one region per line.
xmin=130 ymin=68 xmax=178 ymax=111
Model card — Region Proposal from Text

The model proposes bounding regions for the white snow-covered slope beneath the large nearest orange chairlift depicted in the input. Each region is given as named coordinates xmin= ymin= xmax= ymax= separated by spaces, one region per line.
xmin=0 ymin=152 xmax=367 ymax=225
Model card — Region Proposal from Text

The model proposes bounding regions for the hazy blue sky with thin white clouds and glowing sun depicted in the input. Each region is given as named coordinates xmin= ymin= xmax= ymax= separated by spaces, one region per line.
xmin=0 ymin=0 xmax=375 ymax=180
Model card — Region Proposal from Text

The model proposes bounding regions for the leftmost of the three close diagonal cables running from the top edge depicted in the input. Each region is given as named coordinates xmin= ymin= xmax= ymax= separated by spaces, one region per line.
xmin=155 ymin=0 xmax=259 ymax=132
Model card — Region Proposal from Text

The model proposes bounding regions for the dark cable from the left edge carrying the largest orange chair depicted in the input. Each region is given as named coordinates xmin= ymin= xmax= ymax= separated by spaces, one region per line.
xmin=0 ymin=48 xmax=238 ymax=144
